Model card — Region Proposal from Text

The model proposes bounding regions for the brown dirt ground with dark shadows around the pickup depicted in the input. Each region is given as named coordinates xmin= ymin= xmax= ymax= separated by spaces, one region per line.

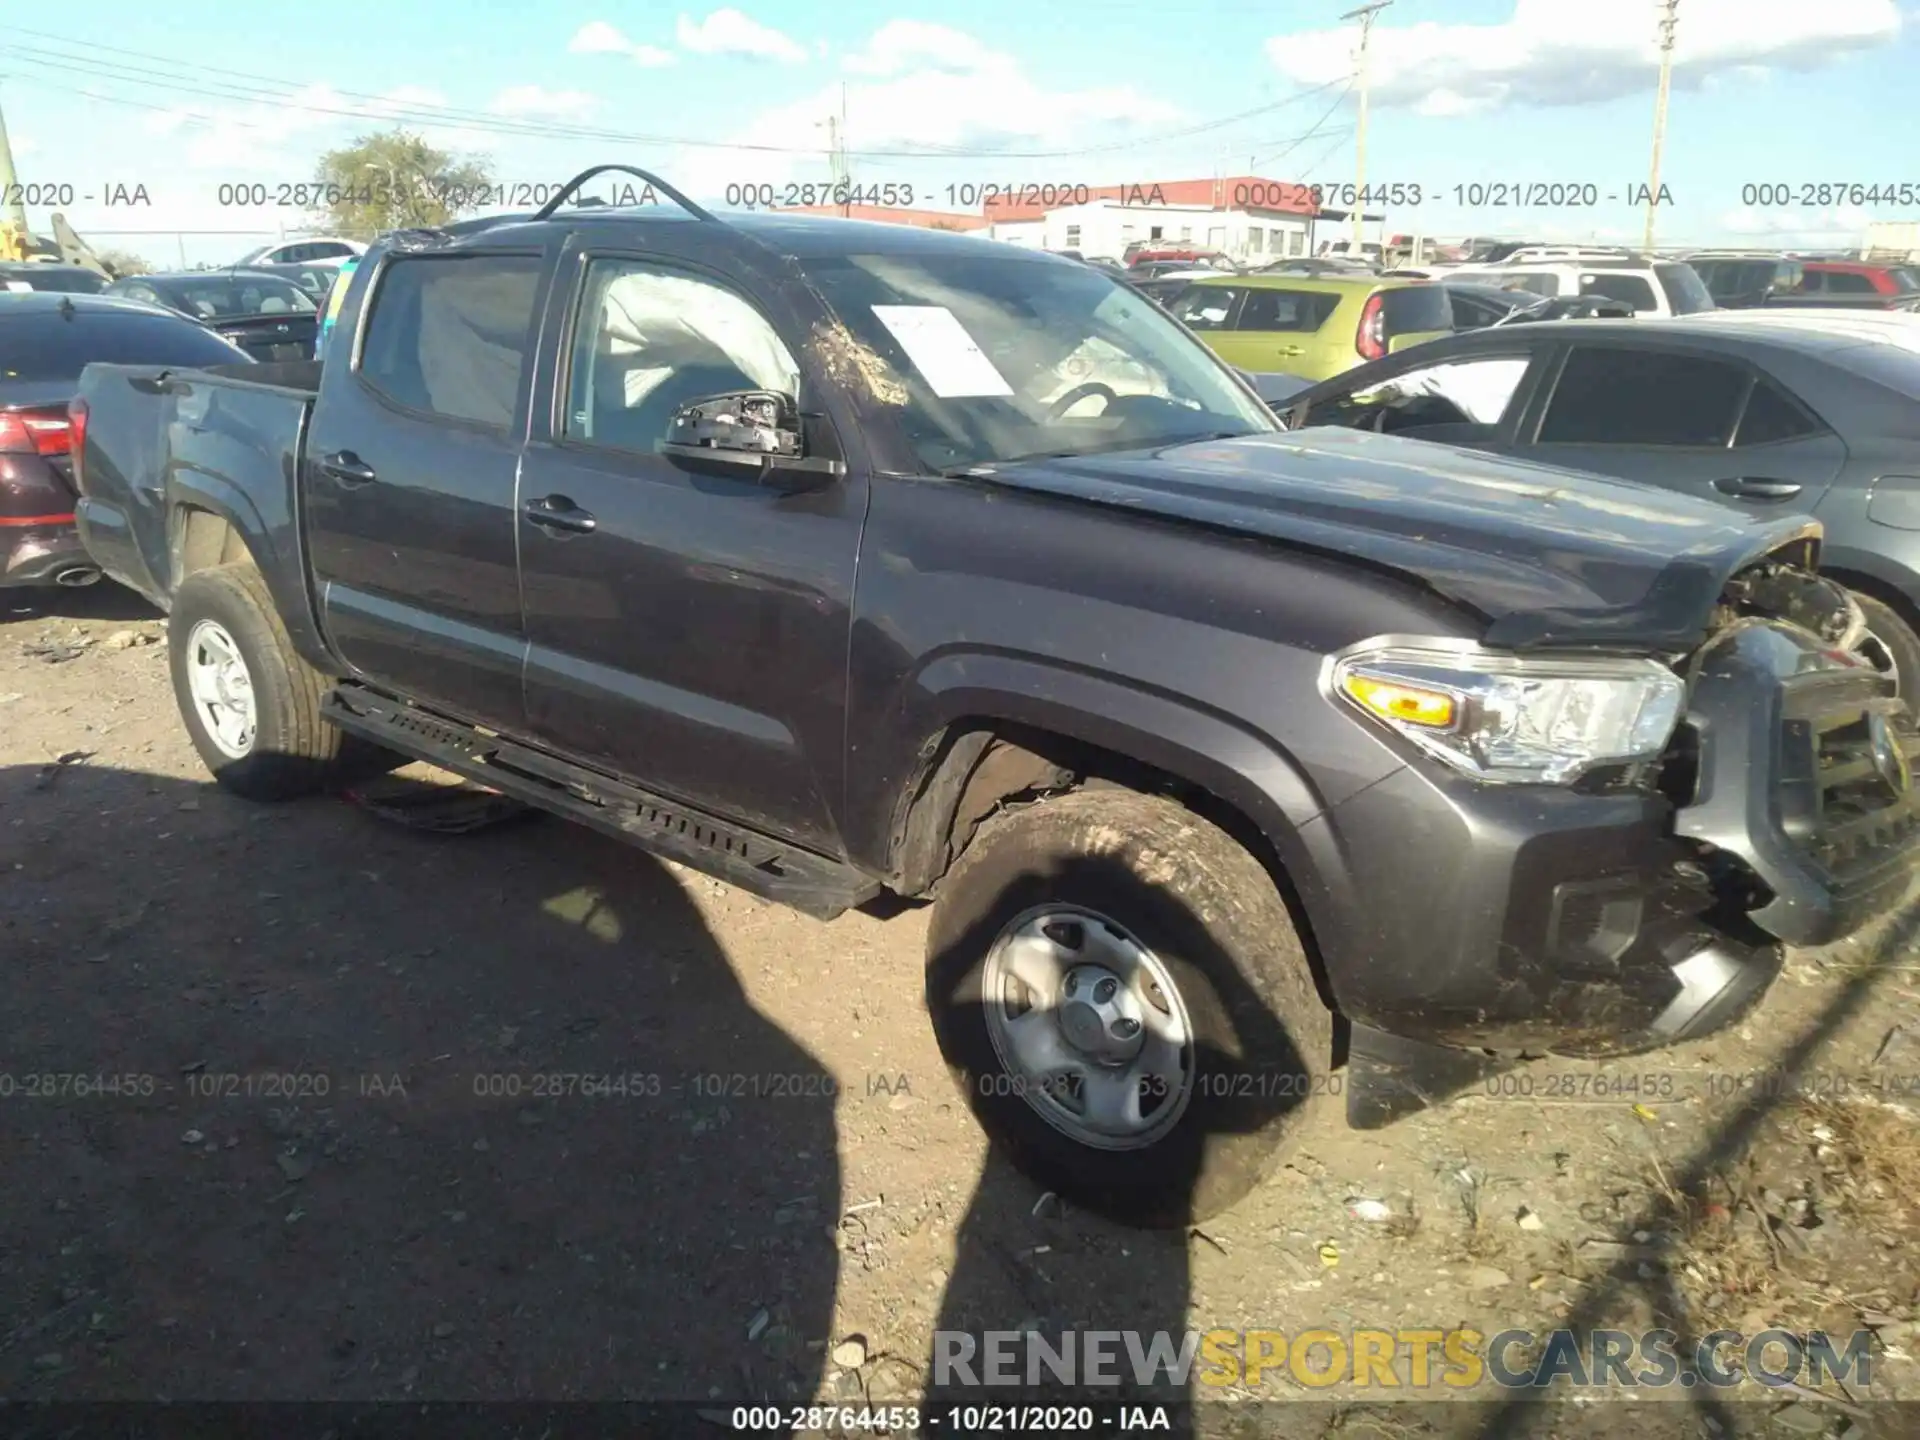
xmin=0 ymin=586 xmax=1920 ymax=1436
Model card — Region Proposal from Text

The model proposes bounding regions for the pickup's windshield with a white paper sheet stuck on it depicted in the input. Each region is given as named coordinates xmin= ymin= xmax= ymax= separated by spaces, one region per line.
xmin=803 ymin=255 xmax=1279 ymax=472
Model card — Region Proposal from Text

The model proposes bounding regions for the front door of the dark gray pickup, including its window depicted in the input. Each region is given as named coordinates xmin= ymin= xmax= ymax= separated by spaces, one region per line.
xmin=520 ymin=255 xmax=866 ymax=851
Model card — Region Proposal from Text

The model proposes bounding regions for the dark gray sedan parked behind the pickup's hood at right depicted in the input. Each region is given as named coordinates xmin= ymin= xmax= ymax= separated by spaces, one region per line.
xmin=1286 ymin=309 xmax=1920 ymax=693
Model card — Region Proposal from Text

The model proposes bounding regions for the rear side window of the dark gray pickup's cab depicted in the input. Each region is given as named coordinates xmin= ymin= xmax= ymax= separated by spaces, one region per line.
xmin=359 ymin=255 xmax=541 ymax=428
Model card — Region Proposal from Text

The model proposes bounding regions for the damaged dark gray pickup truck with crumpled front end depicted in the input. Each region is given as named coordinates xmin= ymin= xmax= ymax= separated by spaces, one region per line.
xmin=79 ymin=167 xmax=1920 ymax=1223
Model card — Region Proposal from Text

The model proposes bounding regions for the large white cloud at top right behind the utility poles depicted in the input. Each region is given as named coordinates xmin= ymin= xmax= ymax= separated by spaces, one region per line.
xmin=1267 ymin=0 xmax=1901 ymax=115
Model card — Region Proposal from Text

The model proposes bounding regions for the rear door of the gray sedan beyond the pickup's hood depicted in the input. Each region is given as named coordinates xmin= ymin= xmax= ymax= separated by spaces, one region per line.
xmin=1517 ymin=342 xmax=1847 ymax=511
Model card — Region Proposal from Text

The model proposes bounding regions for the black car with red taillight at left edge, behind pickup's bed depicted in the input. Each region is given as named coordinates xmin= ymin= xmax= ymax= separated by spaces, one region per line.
xmin=0 ymin=290 xmax=246 ymax=586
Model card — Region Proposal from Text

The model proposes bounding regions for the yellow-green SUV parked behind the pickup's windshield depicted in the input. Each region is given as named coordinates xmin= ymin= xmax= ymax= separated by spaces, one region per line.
xmin=1167 ymin=275 xmax=1453 ymax=380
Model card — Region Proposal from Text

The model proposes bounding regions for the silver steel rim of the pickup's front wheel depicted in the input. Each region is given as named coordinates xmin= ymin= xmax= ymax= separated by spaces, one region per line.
xmin=981 ymin=904 xmax=1194 ymax=1150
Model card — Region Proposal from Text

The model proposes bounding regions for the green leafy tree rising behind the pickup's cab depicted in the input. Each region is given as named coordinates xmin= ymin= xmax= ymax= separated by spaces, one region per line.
xmin=313 ymin=129 xmax=493 ymax=240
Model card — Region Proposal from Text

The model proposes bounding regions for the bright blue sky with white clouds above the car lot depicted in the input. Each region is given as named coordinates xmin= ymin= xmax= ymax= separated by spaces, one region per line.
xmin=0 ymin=0 xmax=1920 ymax=263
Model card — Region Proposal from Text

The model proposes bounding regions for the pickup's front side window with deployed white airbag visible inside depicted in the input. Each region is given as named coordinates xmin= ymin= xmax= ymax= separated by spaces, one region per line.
xmin=564 ymin=259 xmax=801 ymax=453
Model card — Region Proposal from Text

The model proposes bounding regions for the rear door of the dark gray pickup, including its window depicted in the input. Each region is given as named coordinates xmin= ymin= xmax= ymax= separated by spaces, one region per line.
xmin=303 ymin=250 xmax=545 ymax=730
